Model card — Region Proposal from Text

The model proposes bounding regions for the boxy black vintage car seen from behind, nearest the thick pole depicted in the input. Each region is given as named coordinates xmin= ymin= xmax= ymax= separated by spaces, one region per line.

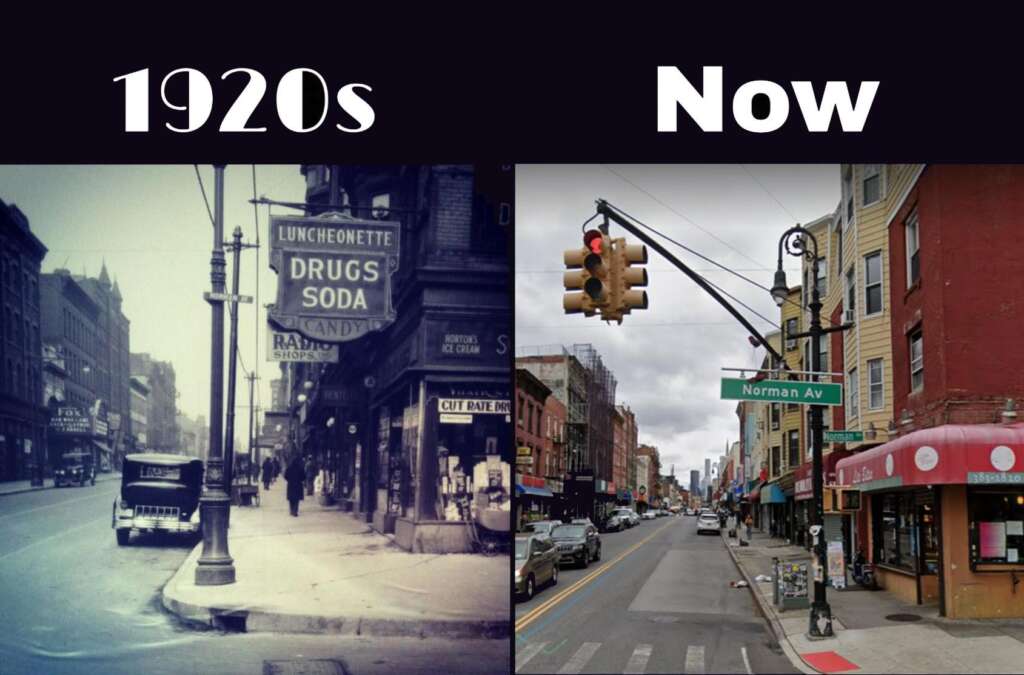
xmin=112 ymin=453 xmax=203 ymax=546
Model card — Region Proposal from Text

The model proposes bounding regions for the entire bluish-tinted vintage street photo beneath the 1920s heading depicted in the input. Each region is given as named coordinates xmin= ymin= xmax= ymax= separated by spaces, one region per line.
xmin=0 ymin=164 xmax=514 ymax=674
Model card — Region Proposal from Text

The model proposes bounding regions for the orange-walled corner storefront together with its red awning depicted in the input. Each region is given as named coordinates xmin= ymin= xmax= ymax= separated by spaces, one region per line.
xmin=837 ymin=424 xmax=1024 ymax=619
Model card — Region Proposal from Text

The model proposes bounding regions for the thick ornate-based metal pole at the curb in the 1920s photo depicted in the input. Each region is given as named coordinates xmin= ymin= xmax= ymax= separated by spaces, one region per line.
xmin=196 ymin=164 xmax=234 ymax=586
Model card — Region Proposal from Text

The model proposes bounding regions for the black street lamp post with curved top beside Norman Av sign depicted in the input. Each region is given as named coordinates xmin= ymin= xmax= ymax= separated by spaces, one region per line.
xmin=771 ymin=224 xmax=849 ymax=638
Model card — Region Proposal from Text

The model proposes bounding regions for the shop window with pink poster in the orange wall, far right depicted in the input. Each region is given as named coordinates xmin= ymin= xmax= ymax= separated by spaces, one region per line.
xmin=968 ymin=488 xmax=1024 ymax=567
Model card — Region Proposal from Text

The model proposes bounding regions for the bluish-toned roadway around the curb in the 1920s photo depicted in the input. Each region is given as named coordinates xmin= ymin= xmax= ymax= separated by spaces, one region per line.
xmin=0 ymin=481 xmax=508 ymax=675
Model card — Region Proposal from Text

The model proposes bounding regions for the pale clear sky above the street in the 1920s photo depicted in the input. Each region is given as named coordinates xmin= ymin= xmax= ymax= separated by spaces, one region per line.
xmin=0 ymin=165 xmax=305 ymax=435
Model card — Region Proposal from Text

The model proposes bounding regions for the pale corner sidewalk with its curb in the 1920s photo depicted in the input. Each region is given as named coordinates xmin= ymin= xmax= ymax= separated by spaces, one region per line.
xmin=163 ymin=480 xmax=512 ymax=639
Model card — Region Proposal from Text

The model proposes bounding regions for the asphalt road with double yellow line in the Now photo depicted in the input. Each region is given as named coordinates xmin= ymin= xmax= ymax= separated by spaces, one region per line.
xmin=515 ymin=516 xmax=798 ymax=673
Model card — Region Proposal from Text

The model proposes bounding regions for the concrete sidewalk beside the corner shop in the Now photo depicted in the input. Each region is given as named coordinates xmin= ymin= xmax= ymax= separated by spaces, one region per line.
xmin=722 ymin=531 xmax=1024 ymax=673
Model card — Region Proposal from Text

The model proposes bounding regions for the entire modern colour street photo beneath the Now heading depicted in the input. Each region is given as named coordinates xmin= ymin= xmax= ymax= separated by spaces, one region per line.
xmin=513 ymin=164 xmax=1024 ymax=674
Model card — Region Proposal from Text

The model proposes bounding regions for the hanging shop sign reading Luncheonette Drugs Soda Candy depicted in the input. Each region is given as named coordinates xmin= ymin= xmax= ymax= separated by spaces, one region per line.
xmin=267 ymin=213 xmax=399 ymax=342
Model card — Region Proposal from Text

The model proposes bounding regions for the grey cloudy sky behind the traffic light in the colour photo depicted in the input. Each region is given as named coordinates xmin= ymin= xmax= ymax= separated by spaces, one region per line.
xmin=515 ymin=164 xmax=840 ymax=485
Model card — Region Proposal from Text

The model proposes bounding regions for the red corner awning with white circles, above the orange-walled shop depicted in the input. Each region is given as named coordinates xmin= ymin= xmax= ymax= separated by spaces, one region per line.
xmin=836 ymin=423 xmax=1024 ymax=492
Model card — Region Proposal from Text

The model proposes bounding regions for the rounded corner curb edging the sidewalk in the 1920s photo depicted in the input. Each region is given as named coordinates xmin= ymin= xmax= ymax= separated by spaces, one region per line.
xmin=160 ymin=543 xmax=512 ymax=639
